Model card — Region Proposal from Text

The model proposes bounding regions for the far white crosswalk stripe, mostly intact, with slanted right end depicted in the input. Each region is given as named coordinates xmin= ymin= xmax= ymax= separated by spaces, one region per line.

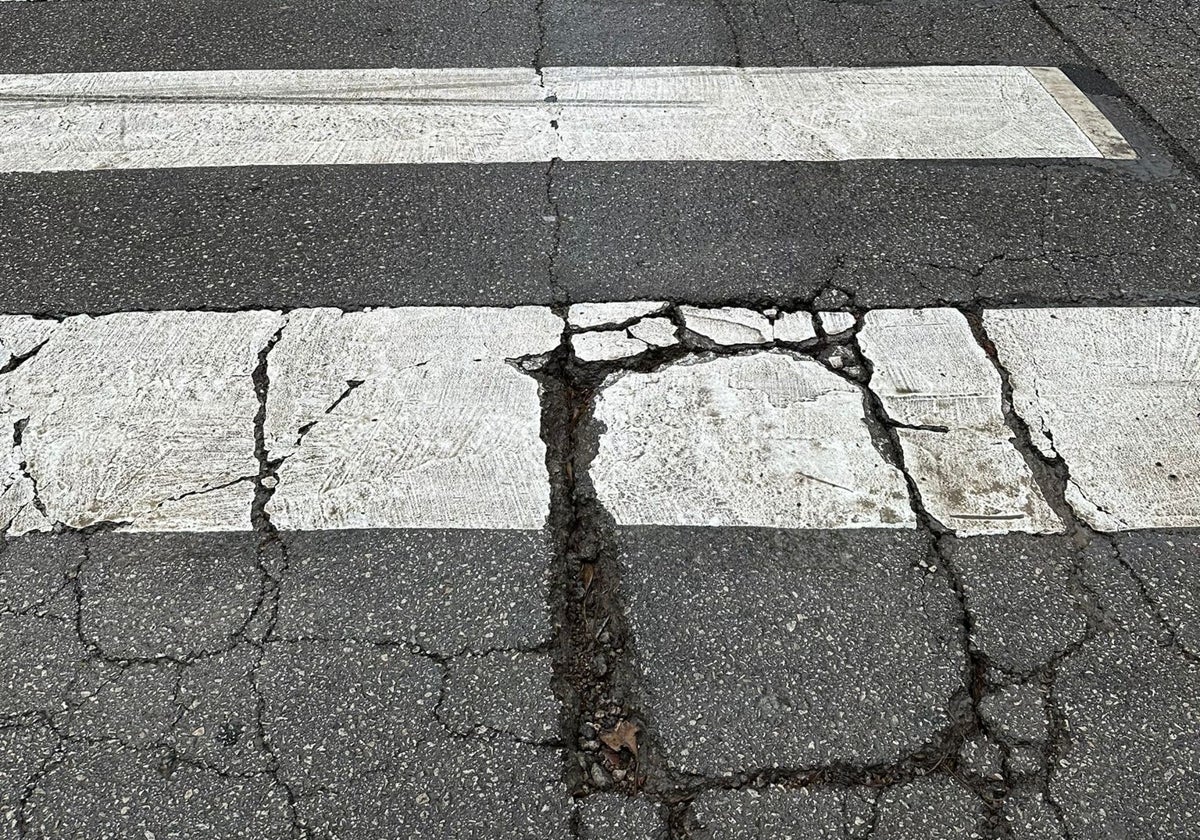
xmin=0 ymin=66 xmax=1132 ymax=172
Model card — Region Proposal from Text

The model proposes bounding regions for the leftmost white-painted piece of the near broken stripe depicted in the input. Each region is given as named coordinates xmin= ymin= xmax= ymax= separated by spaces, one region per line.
xmin=0 ymin=312 xmax=281 ymax=533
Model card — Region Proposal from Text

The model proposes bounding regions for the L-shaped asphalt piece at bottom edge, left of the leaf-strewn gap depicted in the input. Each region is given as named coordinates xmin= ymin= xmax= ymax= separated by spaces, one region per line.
xmin=259 ymin=642 xmax=571 ymax=840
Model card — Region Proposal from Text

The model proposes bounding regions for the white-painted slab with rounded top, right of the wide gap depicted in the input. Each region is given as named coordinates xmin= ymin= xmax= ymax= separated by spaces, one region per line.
xmin=590 ymin=352 xmax=914 ymax=528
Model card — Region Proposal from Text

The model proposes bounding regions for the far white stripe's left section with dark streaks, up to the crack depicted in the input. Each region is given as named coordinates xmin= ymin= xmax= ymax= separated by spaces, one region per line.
xmin=0 ymin=68 xmax=557 ymax=172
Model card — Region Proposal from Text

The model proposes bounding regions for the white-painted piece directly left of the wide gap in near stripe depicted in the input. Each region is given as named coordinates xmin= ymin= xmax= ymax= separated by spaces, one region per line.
xmin=265 ymin=306 xmax=563 ymax=530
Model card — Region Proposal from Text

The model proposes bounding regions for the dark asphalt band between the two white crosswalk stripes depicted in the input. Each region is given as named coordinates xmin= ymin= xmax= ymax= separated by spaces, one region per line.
xmin=0 ymin=149 xmax=1200 ymax=314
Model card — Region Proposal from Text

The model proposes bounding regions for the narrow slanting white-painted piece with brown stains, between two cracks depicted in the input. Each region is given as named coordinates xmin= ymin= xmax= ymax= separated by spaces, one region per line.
xmin=858 ymin=308 xmax=1063 ymax=535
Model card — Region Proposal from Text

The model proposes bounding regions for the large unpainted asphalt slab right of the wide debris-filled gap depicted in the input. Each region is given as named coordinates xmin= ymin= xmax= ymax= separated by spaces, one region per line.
xmin=616 ymin=527 xmax=966 ymax=778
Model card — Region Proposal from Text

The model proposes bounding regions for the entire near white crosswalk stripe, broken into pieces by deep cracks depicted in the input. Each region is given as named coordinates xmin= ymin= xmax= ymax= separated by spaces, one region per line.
xmin=0 ymin=306 xmax=1200 ymax=535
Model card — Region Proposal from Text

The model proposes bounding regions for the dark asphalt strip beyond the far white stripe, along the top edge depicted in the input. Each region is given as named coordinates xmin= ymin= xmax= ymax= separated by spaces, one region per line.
xmin=0 ymin=0 xmax=1074 ymax=73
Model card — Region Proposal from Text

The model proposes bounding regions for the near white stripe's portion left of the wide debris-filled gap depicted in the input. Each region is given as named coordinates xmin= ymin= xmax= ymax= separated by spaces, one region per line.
xmin=0 ymin=307 xmax=563 ymax=533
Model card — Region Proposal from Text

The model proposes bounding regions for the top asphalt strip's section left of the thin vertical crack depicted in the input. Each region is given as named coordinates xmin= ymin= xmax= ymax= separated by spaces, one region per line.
xmin=0 ymin=0 xmax=538 ymax=73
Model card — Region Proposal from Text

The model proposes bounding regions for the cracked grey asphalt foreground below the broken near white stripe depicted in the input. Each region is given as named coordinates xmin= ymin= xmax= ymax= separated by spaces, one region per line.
xmin=0 ymin=527 xmax=1200 ymax=840
